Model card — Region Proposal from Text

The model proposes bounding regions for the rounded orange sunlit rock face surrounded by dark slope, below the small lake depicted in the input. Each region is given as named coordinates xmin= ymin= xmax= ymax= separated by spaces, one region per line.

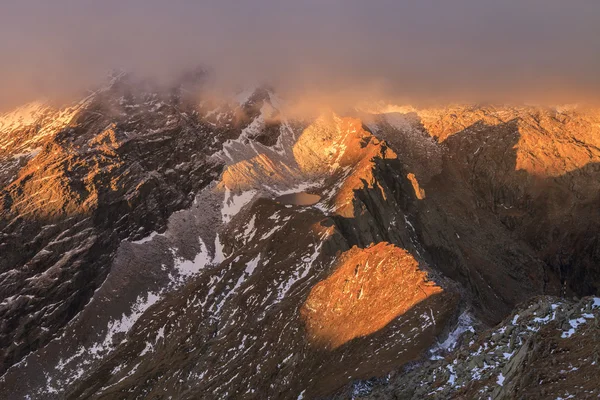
xmin=300 ymin=243 xmax=442 ymax=348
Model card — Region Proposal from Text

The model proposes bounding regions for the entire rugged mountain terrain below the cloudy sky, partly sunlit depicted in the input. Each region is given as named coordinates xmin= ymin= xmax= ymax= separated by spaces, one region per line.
xmin=0 ymin=80 xmax=600 ymax=399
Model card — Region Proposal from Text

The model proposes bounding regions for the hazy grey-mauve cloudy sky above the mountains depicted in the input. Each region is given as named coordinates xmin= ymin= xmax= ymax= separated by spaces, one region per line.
xmin=0 ymin=0 xmax=600 ymax=109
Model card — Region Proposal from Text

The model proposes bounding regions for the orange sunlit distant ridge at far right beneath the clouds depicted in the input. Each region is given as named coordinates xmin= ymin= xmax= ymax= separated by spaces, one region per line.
xmin=394 ymin=105 xmax=600 ymax=177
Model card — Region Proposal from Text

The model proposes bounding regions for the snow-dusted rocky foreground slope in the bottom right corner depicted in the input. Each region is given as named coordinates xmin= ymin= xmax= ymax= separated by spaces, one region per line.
xmin=357 ymin=297 xmax=600 ymax=399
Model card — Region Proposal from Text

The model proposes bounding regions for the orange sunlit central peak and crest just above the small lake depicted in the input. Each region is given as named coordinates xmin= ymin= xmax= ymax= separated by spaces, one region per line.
xmin=220 ymin=114 xmax=397 ymax=205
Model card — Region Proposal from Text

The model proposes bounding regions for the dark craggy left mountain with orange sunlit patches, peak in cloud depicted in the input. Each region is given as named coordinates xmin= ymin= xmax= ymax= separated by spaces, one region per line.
xmin=0 ymin=76 xmax=266 ymax=376
